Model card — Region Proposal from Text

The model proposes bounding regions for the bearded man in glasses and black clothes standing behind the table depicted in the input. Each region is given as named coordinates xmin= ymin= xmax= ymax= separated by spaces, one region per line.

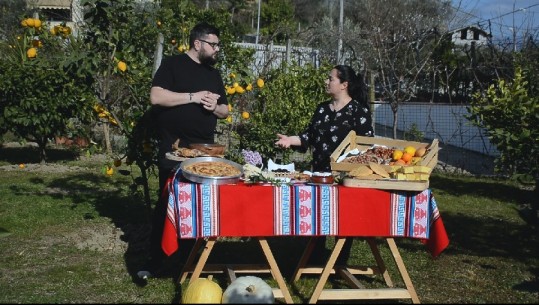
xmin=138 ymin=22 xmax=228 ymax=278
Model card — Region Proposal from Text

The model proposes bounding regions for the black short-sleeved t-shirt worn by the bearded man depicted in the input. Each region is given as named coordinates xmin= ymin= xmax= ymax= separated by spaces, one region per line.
xmin=152 ymin=53 xmax=228 ymax=170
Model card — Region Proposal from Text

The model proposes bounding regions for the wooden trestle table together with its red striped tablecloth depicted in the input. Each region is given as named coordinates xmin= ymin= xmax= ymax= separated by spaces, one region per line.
xmin=162 ymin=170 xmax=449 ymax=303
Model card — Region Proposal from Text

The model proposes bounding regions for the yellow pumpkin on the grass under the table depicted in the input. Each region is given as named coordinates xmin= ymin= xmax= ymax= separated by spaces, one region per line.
xmin=182 ymin=278 xmax=223 ymax=304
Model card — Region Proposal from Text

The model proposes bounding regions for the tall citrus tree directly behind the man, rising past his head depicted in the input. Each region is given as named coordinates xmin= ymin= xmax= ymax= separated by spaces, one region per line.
xmin=80 ymin=0 xmax=260 ymax=204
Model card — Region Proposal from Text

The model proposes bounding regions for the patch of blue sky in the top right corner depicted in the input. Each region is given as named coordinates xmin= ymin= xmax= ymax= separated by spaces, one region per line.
xmin=451 ymin=0 xmax=539 ymax=40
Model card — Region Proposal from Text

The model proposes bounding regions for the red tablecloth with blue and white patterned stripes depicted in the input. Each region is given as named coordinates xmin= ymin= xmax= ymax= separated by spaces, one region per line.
xmin=162 ymin=172 xmax=449 ymax=257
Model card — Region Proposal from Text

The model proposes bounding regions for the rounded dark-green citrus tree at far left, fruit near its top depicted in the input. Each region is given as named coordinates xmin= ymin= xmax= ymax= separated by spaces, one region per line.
xmin=0 ymin=18 xmax=93 ymax=163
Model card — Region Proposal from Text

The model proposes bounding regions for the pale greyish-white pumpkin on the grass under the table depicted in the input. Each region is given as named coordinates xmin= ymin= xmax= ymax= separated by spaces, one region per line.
xmin=222 ymin=276 xmax=275 ymax=304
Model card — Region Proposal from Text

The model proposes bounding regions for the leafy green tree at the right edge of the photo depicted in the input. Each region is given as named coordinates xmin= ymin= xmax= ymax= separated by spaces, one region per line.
xmin=468 ymin=62 xmax=539 ymax=188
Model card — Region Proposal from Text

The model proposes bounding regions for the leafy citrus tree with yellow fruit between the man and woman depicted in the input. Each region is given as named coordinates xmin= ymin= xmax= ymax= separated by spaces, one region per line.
xmin=227 ymin=63 xmax=330 ymax=167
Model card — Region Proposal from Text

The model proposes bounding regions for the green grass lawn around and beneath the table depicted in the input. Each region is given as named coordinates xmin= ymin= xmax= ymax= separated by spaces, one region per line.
xmin=0 ymin=148 xmax=539 ymax=304
